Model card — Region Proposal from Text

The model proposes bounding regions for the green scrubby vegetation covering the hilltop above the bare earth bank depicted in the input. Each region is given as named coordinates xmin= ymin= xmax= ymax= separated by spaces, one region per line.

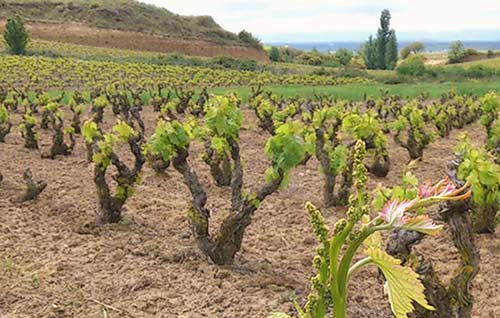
xmin=0 ymin=0 xmax=249 ymax=46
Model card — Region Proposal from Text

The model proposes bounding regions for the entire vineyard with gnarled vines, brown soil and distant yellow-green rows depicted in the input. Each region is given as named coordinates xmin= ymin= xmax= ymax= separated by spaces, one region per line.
xmin=0 ymin=56 xmax=500 ymax=318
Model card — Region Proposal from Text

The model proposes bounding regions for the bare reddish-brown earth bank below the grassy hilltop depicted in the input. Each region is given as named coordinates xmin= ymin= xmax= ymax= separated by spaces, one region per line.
xmin=0 ymin=19 xmax=268 ymax=62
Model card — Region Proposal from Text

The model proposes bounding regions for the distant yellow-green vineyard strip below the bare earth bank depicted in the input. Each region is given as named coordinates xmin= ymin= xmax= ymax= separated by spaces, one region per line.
xmin=0 ymin=56 xmax=366 ymax=93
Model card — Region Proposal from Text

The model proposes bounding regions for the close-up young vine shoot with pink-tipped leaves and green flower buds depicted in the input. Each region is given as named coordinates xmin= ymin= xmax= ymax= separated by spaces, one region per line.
xmin=274 ymin=141 xmax=470 ymax=318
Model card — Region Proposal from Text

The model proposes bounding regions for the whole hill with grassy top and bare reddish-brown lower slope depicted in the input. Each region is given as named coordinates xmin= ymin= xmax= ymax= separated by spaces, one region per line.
xmin=0 ymin=0 xmax=267 ymax=61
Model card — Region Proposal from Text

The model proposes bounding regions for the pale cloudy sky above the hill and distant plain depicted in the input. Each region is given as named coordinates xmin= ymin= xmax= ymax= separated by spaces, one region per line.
xmin=142 ymin=0 xmax=500 ymax=43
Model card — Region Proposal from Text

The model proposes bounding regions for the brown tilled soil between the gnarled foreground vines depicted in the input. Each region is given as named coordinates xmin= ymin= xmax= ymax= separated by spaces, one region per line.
xmin=0 ymin=110 xmax=500 ymax=318
